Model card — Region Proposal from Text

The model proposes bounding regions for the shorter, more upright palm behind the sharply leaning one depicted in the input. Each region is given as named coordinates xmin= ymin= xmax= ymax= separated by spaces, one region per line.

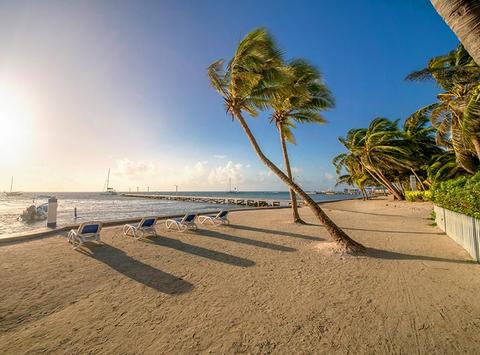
xmin=269 ymin=59 xmax=335 ymax=223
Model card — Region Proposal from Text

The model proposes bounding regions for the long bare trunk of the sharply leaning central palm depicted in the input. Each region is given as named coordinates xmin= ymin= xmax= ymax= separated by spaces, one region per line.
xmin=235 ymin=111 xmax=365 ymax=253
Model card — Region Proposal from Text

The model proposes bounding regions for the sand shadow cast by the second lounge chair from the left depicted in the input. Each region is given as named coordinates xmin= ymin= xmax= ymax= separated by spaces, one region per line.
xmin=143 ymin=237 xmax=255 ymax=267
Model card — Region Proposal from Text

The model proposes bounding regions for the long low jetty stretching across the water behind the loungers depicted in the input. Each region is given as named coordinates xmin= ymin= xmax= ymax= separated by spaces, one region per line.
xmin=122 ymin=193 xmax=291 ymax=207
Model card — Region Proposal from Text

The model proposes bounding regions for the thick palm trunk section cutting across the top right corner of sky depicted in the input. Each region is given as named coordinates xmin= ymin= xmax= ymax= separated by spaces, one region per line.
xmin=430 ymin=0 xmax=480 ymax=65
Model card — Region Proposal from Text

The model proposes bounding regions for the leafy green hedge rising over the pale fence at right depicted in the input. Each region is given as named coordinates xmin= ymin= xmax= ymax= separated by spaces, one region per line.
xmin=431 ymin=171 xmax=480 ymax=218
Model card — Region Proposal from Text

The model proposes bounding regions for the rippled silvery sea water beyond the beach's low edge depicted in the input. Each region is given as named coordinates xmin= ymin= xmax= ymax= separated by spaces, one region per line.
xmin=0 ymin=191 xmax=357 ymax=236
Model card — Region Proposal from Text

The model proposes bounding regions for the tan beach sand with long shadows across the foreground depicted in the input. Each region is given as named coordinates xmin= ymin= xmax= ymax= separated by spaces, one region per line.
xmin=0 ymin=200 xmax=480 ymax=354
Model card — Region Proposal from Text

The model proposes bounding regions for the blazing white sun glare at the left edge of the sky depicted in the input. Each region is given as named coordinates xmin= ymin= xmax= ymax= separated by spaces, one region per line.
xmin=0 ymin=84 xmax=33 ymax=164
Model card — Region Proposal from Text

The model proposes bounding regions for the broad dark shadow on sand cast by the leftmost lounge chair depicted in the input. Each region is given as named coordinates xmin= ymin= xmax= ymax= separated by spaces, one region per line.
xmin=77 ymin=244 xmax=193 ymax=295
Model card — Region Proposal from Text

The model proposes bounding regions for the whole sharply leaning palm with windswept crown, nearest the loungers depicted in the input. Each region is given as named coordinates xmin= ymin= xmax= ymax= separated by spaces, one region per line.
xmin=208 ymin=29 xmax=365 ymax=253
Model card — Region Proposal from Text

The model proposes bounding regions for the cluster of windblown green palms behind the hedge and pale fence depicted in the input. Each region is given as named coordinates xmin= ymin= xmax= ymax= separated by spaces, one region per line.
xmin=333 ymin=45 xmax=480 ymax=200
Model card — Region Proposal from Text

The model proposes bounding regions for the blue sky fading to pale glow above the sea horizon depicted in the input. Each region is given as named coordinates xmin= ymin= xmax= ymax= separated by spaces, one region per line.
xmin=0 ymin=0 xmax=458 ymax=191
